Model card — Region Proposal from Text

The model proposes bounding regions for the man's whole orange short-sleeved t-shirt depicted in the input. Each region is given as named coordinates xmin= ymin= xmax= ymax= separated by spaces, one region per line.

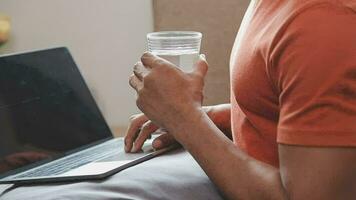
xmin=230 ymin=0 xmax=356 ymax=167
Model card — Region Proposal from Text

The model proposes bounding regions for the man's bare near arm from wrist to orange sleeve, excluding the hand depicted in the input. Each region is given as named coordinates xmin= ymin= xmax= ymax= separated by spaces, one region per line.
xmin=174 ymin=111 xmax=356 ymax=200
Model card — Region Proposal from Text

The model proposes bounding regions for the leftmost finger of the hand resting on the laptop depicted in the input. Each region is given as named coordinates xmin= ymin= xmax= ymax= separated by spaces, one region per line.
xmin=125 ymin=114 xmax=148 ymax=152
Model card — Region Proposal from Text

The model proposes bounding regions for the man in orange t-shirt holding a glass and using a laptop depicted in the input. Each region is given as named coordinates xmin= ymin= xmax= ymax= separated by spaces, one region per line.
xmin=125 ymin=0 xmax=356 ymax=200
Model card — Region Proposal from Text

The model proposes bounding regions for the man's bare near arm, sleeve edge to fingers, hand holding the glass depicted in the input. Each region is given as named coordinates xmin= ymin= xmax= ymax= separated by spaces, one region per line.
xmin=130 ymin=53 xmax=356 ymax=200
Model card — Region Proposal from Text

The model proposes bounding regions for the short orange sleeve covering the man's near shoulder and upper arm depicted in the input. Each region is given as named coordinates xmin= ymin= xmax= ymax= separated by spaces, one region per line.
xmin=270 ymin=5 xmax=356 ymax=146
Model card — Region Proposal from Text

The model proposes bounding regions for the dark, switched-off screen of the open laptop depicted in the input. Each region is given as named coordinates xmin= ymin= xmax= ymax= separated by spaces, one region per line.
xmin=0 ymin=48 xmax=112 ymax=174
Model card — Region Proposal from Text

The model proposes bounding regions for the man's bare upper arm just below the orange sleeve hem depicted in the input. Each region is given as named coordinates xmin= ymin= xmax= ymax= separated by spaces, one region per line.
xmin=279 ymin=145 xmax=356 ymax=199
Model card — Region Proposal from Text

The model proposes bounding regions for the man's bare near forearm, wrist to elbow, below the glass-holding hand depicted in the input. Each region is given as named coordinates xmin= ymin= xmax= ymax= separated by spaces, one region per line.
xmin=175 ymin=113 xmax=287 ymax=200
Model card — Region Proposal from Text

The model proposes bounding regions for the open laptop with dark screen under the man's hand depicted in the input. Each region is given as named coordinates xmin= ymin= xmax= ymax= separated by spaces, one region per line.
xmin=0 ymin=47 xmax=172 ymax=184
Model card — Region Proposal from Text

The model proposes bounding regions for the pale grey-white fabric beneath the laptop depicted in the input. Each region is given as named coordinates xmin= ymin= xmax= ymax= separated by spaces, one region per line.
xmin=0 ymin=150 xmax=223 ymax=200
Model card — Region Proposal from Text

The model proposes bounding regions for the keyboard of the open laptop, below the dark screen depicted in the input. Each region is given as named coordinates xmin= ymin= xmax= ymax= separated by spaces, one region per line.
xmin=12 ymin=139 xmax=123 ymax=179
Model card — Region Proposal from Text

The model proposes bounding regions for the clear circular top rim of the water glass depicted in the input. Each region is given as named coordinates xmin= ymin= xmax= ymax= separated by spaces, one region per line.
xmin=147 ymin=31 xmax=202 ymax=40
